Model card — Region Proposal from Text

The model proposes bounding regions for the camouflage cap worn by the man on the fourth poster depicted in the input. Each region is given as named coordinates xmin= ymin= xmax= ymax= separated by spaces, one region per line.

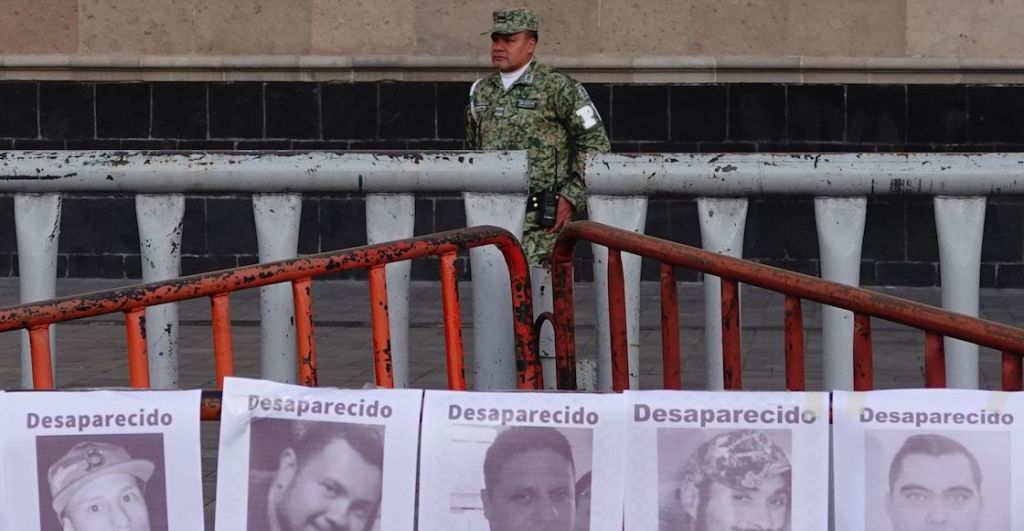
xmin=683 ymin=430 xmax=792 ymax=489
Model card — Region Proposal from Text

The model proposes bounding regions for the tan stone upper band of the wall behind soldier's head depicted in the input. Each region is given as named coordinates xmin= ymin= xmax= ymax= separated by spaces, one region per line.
xmin=0 ymin=0 xmax=1024 ymax=58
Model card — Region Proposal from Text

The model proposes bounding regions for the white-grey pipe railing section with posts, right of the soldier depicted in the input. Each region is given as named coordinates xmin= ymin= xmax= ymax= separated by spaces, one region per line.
xmin=587 ymin=153 xmax=1024 ymax=390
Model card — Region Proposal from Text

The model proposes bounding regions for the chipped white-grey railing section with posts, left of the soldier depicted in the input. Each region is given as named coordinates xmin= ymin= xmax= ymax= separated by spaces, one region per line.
xmin=0 ymin=151 xmax=528 ymax=389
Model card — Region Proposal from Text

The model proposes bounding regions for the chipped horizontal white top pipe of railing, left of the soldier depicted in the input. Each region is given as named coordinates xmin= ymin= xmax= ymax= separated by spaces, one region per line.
xmin=0 ymin=150 xmax=526 ymax=193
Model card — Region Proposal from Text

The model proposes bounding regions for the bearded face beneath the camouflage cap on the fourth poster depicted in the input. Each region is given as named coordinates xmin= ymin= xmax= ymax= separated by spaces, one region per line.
xmin=698 ymin=476 xmax=790 ymax=531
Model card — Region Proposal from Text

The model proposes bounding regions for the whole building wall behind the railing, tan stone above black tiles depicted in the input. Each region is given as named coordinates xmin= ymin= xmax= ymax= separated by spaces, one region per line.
xmin=0 ymin=0 xmax=1024 ymax=286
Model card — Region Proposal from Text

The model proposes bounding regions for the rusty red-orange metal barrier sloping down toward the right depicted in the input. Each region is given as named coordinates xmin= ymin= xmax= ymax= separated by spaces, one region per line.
xmin=551 ymin=221 xmax=1024 ymax=391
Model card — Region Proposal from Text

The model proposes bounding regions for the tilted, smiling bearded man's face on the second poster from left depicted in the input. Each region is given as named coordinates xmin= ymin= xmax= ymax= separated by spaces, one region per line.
xmin=275 ymin=439 xmax=381 ymax=531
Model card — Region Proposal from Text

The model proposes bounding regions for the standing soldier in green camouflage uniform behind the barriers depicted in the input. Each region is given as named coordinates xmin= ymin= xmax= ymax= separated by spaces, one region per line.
xmin=466 ymin=8 xmax=610 ymax=266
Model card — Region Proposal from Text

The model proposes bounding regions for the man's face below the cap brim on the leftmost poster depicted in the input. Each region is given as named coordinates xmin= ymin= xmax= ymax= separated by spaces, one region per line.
xmin=61 ymin=474 xmax=150 ymax=531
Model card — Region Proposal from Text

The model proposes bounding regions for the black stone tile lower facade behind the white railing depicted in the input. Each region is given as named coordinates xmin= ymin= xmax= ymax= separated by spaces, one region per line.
xmin=0 ymin=82 xmax=1024 ymax=287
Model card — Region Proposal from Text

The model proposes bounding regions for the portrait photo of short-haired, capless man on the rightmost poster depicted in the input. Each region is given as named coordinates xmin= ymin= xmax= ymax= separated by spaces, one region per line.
xmin=864 ymin=430 xmax=1011 ymax=531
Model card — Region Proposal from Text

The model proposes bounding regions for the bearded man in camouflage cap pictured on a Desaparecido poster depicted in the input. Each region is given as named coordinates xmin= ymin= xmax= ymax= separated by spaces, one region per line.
xmin=660 ymin=430 xmax=793 ymax=531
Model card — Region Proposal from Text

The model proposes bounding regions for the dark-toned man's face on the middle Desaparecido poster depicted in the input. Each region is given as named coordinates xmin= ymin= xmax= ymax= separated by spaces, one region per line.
xmin=480 ymin=450 xmax=575 ymax=531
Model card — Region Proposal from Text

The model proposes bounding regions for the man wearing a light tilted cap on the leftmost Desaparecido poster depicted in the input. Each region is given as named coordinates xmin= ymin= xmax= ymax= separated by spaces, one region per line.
xmin=47 ymin=442 xmax=154 ymax=531
